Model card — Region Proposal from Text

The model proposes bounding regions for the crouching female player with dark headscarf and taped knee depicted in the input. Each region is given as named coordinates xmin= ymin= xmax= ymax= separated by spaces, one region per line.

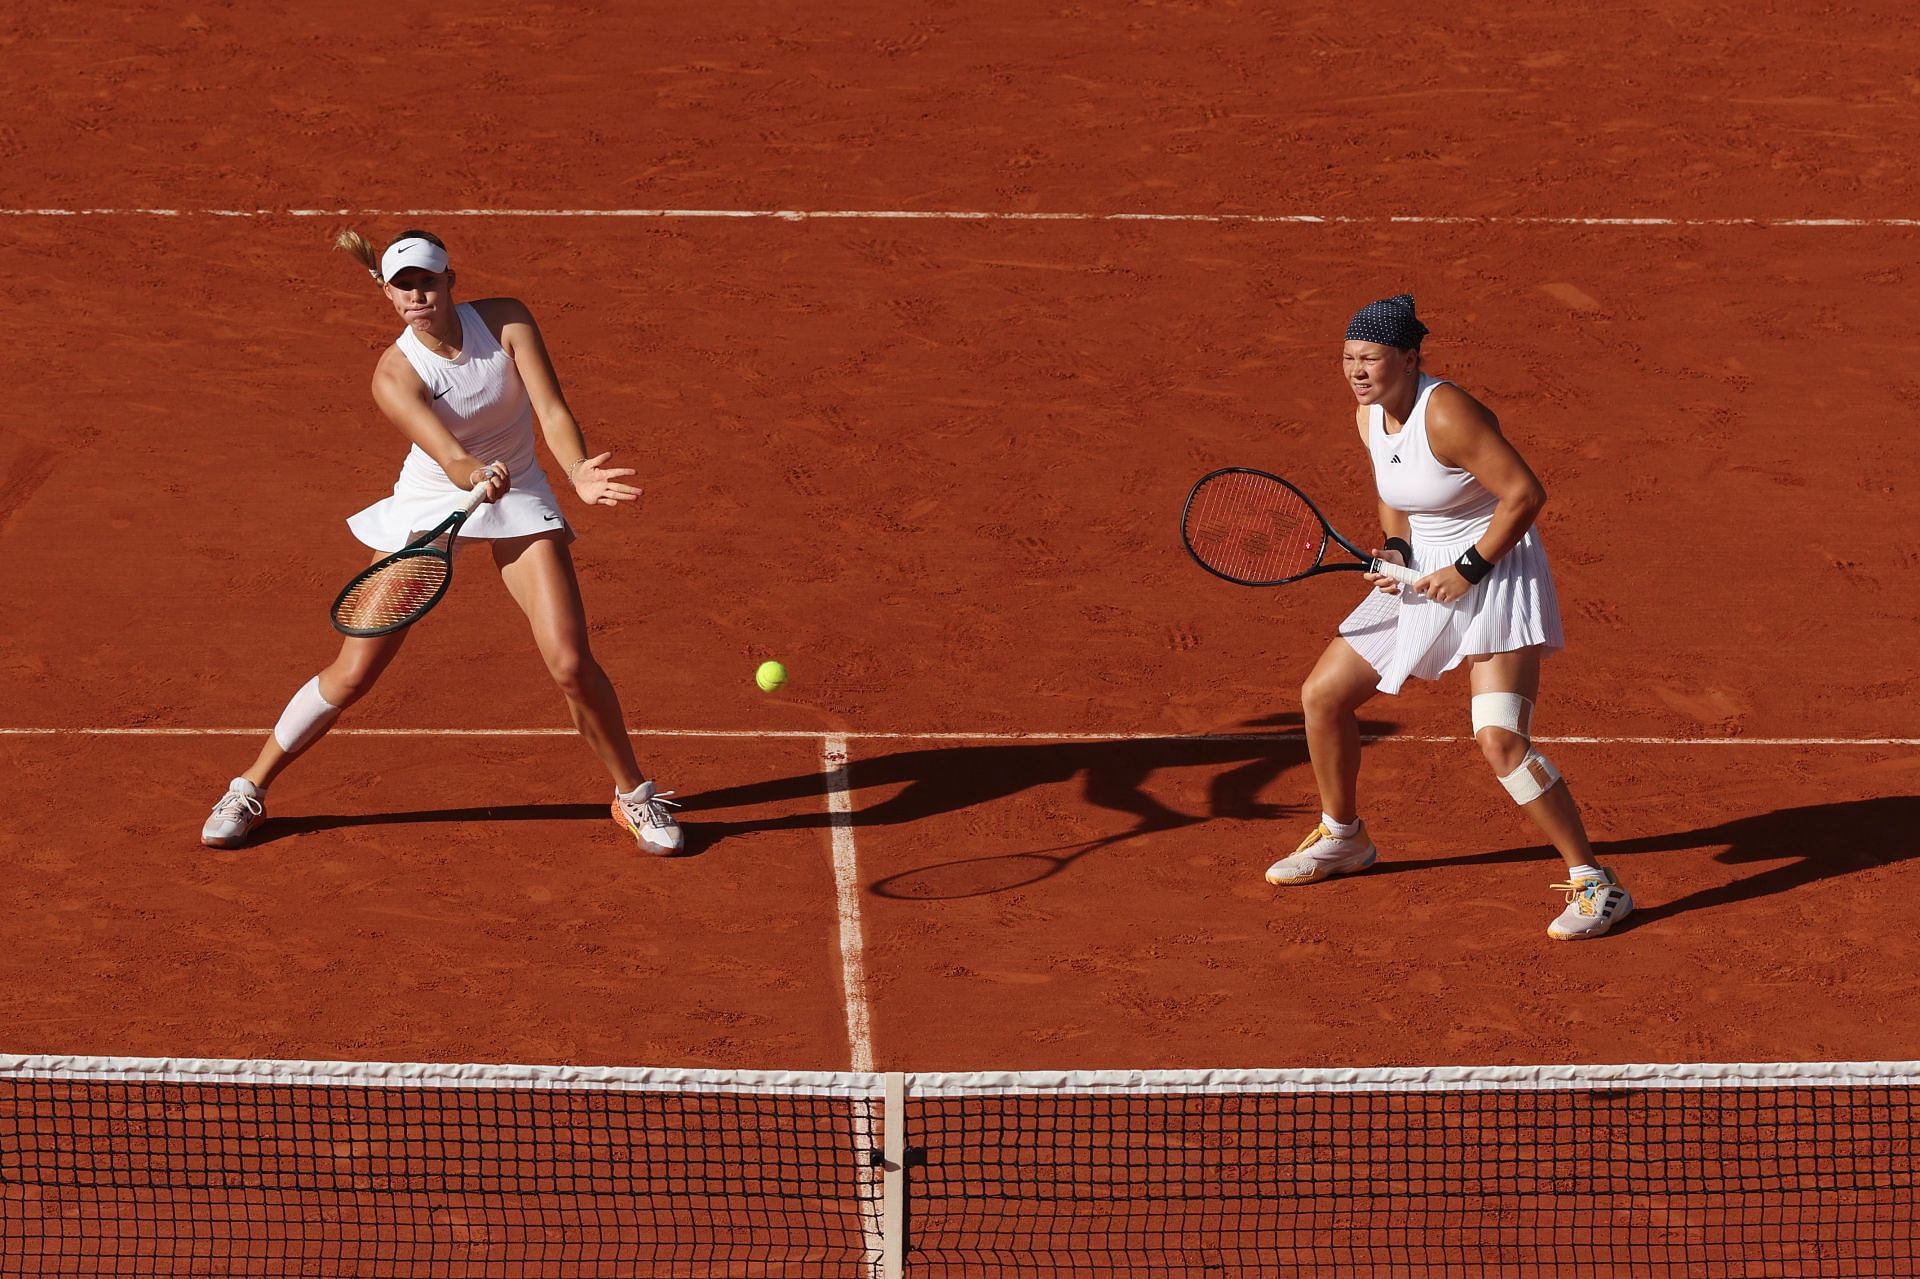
xmin=1267 ymin=294 xmax=1634 ymax=941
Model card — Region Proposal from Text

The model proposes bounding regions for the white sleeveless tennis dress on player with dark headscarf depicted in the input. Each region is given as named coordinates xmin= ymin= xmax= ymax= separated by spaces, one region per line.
xmin=1340 ymin=374 xmax=1567 ymax=693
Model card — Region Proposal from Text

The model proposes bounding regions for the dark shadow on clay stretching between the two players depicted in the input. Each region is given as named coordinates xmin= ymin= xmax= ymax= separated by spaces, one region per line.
xmin=684 ymin=712 xmax=1392 ymax=883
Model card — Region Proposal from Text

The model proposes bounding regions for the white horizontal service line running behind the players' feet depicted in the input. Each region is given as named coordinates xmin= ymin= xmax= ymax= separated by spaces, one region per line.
xmin=0 ymin=728 xmax=1920 ymax=749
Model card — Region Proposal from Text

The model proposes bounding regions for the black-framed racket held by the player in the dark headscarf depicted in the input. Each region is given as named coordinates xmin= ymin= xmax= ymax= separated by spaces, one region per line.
xmin=1181 ymin=467 xmax=1423 ymax=586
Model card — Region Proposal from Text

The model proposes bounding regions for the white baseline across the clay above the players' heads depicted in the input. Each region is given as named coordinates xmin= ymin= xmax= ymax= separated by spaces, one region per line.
xmin=0 ymin=209 xmax=1920 ymax=229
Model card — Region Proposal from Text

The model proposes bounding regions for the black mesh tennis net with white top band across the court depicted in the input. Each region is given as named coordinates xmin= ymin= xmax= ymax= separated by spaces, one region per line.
xmin=0 ymin=1056 xmax=1920 ymax=1279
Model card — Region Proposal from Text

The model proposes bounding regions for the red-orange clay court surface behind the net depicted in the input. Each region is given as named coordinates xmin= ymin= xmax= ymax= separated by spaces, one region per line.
xmin=0 ymin=4 xmax=1920 ymax=1070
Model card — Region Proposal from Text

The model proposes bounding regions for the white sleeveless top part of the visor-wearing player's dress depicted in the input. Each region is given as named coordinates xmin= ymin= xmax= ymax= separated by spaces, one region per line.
xmin=394 ymin=302 xmax=534 ymax=490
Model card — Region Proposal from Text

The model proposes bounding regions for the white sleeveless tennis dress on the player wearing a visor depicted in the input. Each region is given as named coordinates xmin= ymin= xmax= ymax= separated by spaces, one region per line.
xmin=348 ymin=302 xmax=574 ymax=551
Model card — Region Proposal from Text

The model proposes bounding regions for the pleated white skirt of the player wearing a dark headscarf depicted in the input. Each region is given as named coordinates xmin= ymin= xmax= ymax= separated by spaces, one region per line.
xmin=1340 ymin=526 xmax=1567 ymax=693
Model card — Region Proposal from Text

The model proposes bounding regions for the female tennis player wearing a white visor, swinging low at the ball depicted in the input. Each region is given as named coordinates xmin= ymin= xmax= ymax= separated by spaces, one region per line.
xmin=200 ymin=230 xmax=684 ymax=855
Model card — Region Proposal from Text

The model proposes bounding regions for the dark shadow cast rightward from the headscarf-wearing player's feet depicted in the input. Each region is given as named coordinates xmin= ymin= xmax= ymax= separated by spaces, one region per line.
xmin=1369 ymin=795 xmax=1920 ymax=928
